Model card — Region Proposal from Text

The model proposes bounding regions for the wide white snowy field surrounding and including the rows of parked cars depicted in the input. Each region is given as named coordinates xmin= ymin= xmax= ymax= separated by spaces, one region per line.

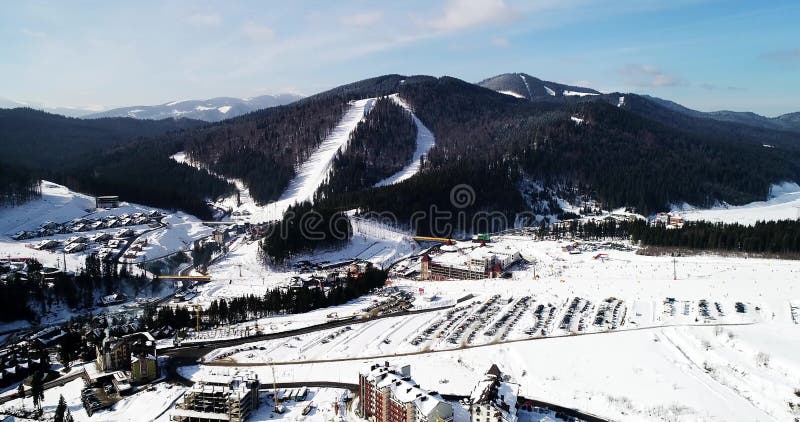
xmin=191 ymin=236 xmax=800 ymax=421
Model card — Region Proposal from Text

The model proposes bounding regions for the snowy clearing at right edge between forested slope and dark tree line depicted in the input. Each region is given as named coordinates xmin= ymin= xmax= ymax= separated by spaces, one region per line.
xmin=674 ymin=182 xmax=800 ymax=225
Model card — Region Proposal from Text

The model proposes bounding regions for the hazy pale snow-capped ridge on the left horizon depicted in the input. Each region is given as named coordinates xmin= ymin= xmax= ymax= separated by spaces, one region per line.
xmin=84 ymin=94 xmax=302 ymax=122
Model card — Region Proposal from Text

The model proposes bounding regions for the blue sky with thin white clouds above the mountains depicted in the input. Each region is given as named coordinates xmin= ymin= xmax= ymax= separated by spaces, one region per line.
xmin=0 ymin=0 xmax=800 ymax=116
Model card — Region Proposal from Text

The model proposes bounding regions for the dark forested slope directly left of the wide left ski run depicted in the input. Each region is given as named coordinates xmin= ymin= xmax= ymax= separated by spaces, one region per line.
xmin=183 ymin=75 xmax=404 ymax=203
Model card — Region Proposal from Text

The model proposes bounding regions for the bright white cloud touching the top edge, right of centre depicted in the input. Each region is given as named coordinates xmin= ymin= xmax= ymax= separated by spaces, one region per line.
xmin=430 ymin=0 xmax=517 ymax=31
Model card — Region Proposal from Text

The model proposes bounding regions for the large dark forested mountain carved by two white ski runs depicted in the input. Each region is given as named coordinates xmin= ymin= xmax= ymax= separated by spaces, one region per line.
xmin=169 ymin=75 xmax=800 ymax=224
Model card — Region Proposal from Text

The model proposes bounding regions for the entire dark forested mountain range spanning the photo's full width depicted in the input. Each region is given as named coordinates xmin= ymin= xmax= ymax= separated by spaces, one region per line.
xmin=0 ymin=73 xmax=800 ymax=229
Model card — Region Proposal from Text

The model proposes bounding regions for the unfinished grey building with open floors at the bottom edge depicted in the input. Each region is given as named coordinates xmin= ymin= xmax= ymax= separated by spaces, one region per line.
xmin=171 ymin=371 xmax=260 ymax=422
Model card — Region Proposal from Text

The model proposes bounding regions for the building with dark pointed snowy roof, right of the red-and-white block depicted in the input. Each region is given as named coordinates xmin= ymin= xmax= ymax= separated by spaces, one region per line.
xmin=469 ymin=364 xmax=519 ymax=422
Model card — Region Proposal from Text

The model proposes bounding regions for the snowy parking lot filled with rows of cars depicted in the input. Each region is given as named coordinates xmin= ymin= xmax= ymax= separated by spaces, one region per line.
xmin=216 ymin=294 xmax=757 ymax=362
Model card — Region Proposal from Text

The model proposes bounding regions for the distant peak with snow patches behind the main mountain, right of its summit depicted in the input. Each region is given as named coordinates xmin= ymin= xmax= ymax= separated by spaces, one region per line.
xmin=478 ymin=73 xmax=600 ymax=100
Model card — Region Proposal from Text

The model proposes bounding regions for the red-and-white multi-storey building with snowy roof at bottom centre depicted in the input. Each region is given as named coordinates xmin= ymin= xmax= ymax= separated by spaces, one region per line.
xmin=358 ymin=362 xmax=453 ymax=422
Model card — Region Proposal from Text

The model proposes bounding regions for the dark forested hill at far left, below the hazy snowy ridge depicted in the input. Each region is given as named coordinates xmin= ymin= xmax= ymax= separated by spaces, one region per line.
xmin=0 ymin=108 xmax=233 ymax=218
